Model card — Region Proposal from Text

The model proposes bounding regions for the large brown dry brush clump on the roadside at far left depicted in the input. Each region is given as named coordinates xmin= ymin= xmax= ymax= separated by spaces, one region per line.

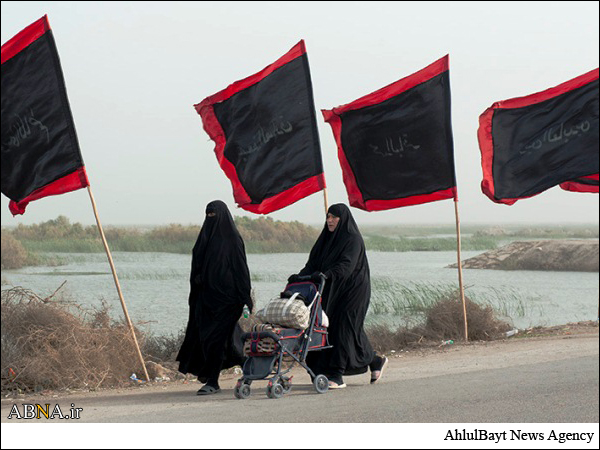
xmin=1 ymin=287 xmax=143 ymax=392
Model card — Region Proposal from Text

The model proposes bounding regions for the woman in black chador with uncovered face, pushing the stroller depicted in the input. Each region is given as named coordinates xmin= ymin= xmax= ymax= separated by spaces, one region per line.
xmin=289 ymin=204 xmax=387 ymax=389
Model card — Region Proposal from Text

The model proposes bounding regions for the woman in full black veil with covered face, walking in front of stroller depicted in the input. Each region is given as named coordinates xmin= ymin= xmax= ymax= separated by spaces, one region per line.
xmin=177 ymin=201 xmax=253 ymax=395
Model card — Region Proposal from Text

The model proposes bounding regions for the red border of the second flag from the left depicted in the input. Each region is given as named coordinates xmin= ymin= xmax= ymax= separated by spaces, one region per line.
xmin=194 ymin=40 xmax=326 ymax=214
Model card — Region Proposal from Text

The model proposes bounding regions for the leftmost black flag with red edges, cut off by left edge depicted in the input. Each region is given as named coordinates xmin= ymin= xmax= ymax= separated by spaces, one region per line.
xmin=1 ymin=16 xmax=89 ymax=215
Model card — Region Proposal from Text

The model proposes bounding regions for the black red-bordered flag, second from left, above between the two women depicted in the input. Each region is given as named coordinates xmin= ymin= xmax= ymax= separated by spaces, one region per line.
xmin=195 ymin=41 xmax=325 ymax=214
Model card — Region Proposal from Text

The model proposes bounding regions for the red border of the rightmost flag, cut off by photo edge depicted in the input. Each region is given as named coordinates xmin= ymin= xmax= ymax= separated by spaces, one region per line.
xmin=477 ymin=69 xmax=599 ymax=205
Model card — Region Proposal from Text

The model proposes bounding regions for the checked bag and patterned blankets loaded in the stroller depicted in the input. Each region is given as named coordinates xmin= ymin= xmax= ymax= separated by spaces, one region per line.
xmin=244 ymin=291 xmax=329 ymax=356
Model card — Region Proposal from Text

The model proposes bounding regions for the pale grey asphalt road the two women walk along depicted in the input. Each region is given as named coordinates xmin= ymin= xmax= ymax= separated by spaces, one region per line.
xmin=1 ymin=333 xmax=599 ymax=423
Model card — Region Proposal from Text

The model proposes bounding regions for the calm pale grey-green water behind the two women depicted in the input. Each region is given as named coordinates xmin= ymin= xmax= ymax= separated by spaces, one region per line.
xmin=2 ymin=252 xmax=598 ymax=334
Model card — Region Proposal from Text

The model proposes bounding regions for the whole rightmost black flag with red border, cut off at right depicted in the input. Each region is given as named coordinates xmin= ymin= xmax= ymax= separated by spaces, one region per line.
xmin=478 ymin=69 xmax=599 ymax=205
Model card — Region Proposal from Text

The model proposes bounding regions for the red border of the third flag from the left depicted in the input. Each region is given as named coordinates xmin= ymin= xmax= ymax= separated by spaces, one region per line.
xmin=321 ymin=55 xmax=458 ymax=211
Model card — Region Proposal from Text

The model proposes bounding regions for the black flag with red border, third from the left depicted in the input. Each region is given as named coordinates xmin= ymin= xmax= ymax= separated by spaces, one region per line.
xmin=323 ymin=56 xmax=456 ymax=211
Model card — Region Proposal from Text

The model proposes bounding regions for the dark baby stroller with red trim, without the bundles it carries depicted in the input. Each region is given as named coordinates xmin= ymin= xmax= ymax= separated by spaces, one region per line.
xmin=234 ymin=274 xmax=331 ymax=399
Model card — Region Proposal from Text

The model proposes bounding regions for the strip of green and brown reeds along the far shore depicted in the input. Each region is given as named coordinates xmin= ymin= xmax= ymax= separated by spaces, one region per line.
xmin=2 ymin=216 xmax=599 ymax=269
